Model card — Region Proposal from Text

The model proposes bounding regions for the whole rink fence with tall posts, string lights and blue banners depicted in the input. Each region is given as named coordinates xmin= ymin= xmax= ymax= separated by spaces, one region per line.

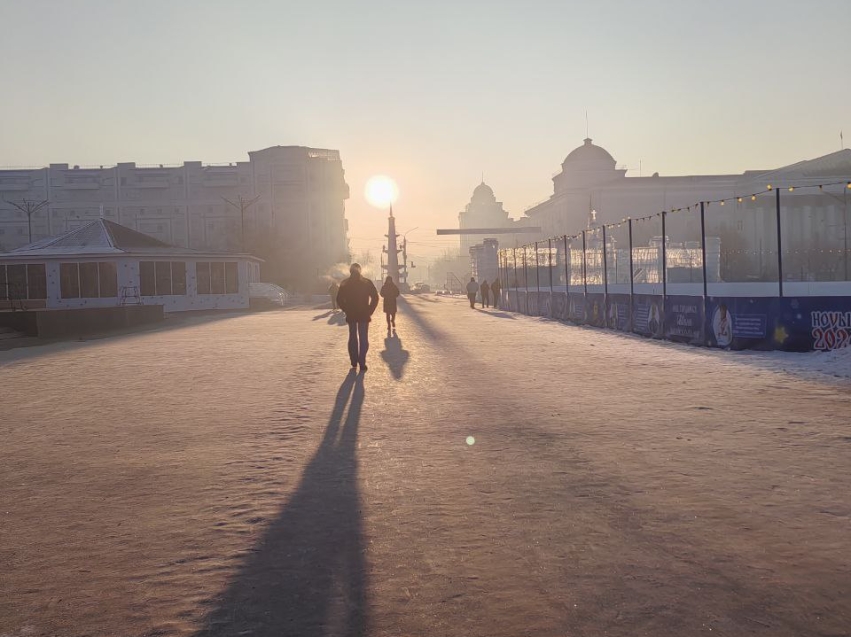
xmin=492 ymin=181 xmax=851 ymax=349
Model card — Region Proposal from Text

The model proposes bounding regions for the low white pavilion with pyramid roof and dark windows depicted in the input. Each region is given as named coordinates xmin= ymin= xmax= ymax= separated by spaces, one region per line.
xmin=0 ymin=219 xmax=260 ymax=312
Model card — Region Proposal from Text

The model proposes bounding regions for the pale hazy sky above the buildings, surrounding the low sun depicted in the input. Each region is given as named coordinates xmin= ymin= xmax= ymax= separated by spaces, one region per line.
xmin=0 ymin=0 xmax=851 ymax=262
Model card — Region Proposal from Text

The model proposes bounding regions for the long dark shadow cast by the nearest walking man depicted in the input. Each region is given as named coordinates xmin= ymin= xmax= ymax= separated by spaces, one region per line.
xmin=197 ymin=372 xmax=367 ymax=637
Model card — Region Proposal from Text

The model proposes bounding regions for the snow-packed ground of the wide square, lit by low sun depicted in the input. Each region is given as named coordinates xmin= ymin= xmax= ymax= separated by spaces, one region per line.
xmin=0 ymin=297 xmax=851 ymax=637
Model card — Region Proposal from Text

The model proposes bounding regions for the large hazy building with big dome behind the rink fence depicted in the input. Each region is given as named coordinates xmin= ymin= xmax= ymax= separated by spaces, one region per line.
xmin=524 ymin=139 xmax=851 ymax=281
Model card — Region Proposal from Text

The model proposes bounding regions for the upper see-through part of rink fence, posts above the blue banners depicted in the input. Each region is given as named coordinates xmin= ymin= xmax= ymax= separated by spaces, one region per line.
xmin=499 ymin=181 xmax=851 ymax=297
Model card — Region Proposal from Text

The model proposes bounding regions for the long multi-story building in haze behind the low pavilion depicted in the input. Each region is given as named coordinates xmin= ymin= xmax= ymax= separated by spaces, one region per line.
xmin=0 ymin=146 xmax=349 ymax=289
